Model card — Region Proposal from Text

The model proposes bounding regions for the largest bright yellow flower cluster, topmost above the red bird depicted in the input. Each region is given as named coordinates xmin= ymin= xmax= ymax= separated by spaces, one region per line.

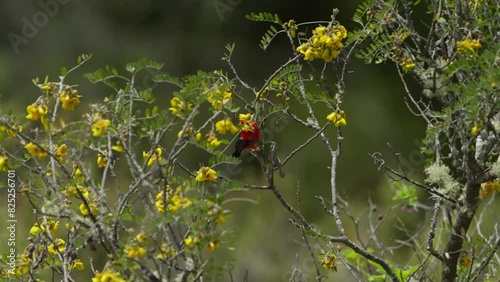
xmin=297 ymin=24 xmax=347 ymax=62
